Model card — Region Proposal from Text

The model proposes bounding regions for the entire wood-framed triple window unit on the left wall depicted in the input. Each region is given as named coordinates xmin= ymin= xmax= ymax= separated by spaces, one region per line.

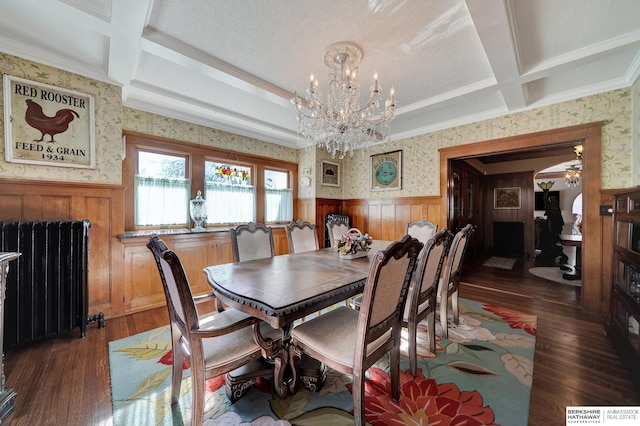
xmin=122 ymin=131 xmax=298 ymax=231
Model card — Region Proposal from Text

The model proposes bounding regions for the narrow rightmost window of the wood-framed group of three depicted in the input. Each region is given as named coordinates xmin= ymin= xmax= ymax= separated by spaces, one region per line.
xmin=264 ymin=170 xmax=293 ymax=222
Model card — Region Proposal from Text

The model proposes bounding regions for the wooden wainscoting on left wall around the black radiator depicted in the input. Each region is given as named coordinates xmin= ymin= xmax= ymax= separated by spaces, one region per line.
xmin=0 ymin=179 xmax=124 ymax=317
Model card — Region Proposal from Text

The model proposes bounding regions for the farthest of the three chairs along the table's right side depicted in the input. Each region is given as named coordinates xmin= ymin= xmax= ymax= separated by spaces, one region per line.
xmin=437 ymin=224 xmax=474 ymax=338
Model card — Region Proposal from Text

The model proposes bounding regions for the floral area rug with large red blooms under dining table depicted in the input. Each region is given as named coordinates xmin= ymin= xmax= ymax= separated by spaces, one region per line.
xmin=109 ymin=299 xmax=536 ymax=426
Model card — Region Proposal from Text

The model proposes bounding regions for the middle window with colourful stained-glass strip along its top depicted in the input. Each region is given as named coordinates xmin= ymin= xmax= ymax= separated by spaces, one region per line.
xmin=204 ymin=161 xmax=256 ymax=224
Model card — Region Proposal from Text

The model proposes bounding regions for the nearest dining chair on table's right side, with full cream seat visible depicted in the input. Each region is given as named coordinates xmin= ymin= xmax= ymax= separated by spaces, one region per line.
xmin=289 ymin=235 xmax=422 ymax=425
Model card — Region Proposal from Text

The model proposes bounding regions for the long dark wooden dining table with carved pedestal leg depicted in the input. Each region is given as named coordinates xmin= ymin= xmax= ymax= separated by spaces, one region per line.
xmin=204 ymin=240 xmax=391 ymax=398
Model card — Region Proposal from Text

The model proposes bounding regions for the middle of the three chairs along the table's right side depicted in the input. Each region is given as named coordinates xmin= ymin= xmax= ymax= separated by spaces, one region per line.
xmin=402 ymin=228 xmax=453 ymax=377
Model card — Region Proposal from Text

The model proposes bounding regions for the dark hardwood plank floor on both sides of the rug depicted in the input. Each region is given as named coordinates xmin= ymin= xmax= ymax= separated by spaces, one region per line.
xmin=5 ymin=255 xmax=640 ymax=426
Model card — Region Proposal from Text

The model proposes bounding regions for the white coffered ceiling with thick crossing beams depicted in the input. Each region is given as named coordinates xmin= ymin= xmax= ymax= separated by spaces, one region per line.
xmin=0 ymin=0 xmax=640 ymax=147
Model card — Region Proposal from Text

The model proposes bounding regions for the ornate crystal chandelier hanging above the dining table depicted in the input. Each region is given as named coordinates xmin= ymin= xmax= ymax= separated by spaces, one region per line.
xmin=291 ymin=41 xmax=396 ymax=158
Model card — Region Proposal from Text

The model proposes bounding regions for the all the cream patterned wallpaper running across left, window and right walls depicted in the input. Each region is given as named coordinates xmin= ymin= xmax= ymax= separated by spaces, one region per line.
xmin=0 ymin=52 xmax=640 ymax=198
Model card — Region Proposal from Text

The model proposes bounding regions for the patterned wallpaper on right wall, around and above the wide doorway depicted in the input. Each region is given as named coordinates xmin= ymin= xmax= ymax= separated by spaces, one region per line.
xmin=336 ymin=87 xmax=640 ymax=199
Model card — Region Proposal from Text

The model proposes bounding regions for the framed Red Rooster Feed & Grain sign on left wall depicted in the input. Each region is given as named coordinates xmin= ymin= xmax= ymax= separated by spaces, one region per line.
xmin=3 ymin=74 xmax=96 ymax=169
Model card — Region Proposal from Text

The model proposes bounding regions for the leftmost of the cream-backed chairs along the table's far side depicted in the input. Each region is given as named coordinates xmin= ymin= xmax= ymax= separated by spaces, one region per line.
xmin=231 ymin=222 xmax=275 ymax=262
